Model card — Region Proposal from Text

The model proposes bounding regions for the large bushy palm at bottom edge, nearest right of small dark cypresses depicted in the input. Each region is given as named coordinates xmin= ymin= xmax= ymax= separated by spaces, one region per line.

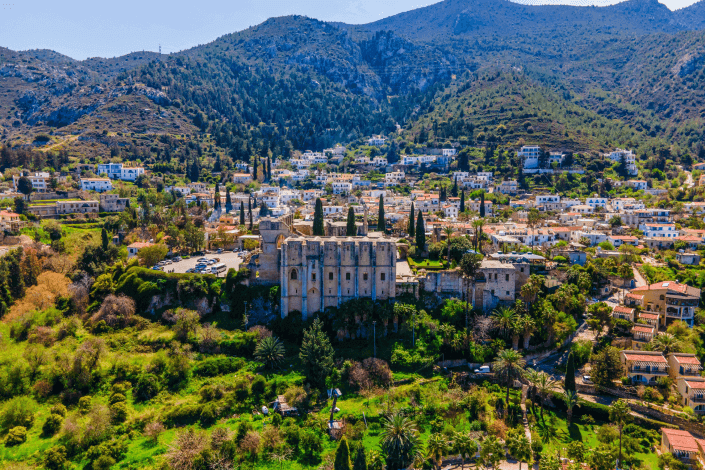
xmin=380 ymin=412 xmax=419 ymax=468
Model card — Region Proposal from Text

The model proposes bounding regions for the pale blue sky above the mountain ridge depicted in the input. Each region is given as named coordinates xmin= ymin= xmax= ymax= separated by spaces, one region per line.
xmin=0 ymin=0 xmax=696 ymax=60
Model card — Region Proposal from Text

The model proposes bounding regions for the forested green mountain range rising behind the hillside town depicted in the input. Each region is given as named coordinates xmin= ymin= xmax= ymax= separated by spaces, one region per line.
xmin=0 ymin=0 xmax=705 ymax=165
